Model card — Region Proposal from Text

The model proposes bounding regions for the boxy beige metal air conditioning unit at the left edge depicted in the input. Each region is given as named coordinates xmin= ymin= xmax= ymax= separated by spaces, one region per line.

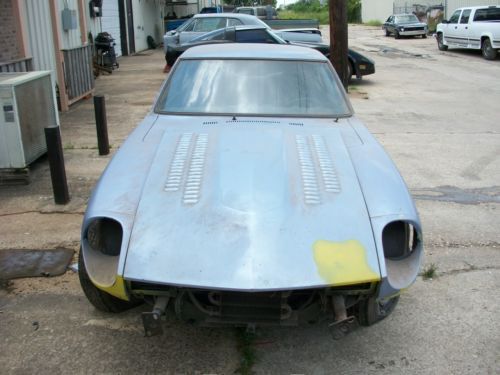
xmin=0 ymin=71 xmax=59 ymax=172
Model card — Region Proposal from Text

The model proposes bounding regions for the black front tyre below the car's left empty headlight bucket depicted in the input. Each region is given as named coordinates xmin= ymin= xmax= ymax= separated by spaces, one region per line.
xmin=78 ymin=249 xmax=141 ymax=313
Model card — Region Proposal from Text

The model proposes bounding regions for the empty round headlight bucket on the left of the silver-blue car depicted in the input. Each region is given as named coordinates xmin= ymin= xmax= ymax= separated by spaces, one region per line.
xmin=86 ymin=218 xmax=123 ymax=256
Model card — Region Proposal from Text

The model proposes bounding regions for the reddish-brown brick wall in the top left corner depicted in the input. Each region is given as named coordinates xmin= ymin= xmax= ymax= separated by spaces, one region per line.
xmin=0 ymin=0 xmax=21 ymax=62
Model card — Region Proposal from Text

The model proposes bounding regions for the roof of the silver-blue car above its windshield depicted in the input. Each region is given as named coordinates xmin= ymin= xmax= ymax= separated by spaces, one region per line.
xmin=180 ymin=43 xmax=328 ymax=61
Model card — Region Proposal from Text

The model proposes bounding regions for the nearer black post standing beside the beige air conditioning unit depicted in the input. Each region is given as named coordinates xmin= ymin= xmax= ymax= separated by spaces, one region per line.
xmin=45 ymin=126 xmax=70 ymax=204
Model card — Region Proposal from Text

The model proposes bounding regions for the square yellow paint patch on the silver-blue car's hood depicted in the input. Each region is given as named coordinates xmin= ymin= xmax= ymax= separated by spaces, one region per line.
xmin=313 ymin=240 xmax=380 ymax=286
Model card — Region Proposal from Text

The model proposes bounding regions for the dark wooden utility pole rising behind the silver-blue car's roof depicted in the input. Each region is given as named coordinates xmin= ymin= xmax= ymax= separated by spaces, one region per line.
xmin=329 ymin=0 xmax=349 ymax=91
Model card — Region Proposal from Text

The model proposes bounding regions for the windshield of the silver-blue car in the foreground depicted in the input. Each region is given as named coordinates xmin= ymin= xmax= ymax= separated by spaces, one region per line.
xmin=155 ymin=59 xmax=351 ymax=117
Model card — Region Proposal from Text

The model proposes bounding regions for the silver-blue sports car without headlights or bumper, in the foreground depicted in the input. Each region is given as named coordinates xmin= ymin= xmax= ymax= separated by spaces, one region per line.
xmin=79 ymin=44 xmax=423 ymax=335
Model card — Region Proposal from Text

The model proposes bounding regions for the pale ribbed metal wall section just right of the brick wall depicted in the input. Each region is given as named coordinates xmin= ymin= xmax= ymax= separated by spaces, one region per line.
xmin=24 ymin=0 xmax=57 ymax=81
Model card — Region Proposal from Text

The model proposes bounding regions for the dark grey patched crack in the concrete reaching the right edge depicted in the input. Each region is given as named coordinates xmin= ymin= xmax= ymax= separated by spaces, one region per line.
xmin=411 ymin=185 xmax=500 ymax=205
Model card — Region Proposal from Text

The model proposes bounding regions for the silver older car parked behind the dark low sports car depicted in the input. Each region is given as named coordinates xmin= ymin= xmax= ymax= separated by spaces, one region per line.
xmin=163 ymin=13 xmax=323 ymax=52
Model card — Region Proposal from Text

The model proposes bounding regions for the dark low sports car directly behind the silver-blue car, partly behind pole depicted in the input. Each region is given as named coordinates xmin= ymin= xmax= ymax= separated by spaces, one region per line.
xmin=165 ymin=26 xmax=375 ymax=79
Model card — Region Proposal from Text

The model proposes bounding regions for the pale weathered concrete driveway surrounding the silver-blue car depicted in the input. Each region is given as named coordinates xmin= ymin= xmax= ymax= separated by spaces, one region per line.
xmin=0 ymin=26 xmax=500 ymax=374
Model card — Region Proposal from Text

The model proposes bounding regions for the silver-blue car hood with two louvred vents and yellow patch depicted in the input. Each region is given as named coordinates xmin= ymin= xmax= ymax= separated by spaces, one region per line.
xmin=124 ymin=117 xmax=380 ymax=291
